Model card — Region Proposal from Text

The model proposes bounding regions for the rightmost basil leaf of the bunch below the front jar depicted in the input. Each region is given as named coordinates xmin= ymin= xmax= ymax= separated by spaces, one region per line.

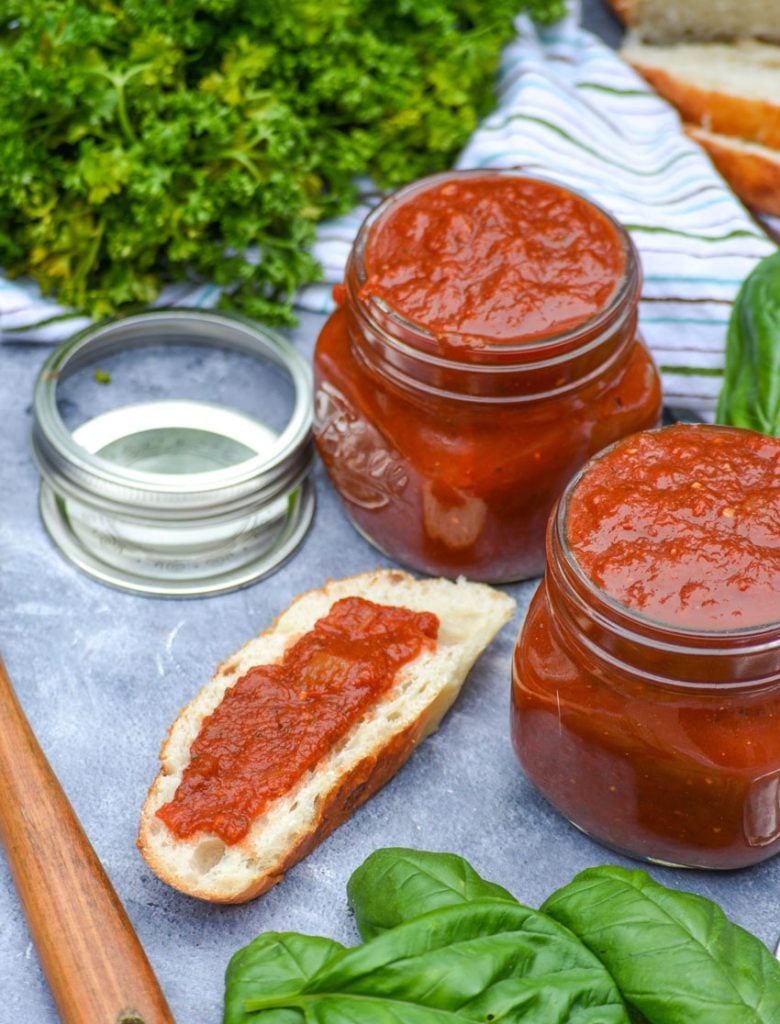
xmin=541 ymin=867 xmax=780 ymax=1024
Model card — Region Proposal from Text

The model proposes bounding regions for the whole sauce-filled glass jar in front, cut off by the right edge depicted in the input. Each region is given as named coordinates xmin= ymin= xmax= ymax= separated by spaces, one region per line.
xmin=512 ymin=425 xmax=780 ymax=868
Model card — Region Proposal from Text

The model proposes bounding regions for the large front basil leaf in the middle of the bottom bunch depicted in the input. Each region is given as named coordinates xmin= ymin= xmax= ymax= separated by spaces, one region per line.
xmin=226 ymin=900 xmax=629 ymax=1024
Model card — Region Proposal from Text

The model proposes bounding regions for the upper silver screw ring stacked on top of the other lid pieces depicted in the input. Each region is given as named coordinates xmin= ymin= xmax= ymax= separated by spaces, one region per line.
xmin=33 ymin=309 xmax=312 ymax=519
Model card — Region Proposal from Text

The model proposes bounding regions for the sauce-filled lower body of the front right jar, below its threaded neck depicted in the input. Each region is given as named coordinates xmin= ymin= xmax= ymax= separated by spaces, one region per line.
xmin=512 ymin=587 xmax=780 ymax=868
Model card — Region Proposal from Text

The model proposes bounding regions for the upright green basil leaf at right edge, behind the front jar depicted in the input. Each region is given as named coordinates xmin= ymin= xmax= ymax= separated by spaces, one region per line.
xmin=716 ymin=252 xmax=780 ymax=437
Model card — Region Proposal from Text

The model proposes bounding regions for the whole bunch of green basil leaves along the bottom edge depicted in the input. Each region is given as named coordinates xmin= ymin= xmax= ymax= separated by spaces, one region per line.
xmin=224 ymin=849 xmax=780 ymax=1024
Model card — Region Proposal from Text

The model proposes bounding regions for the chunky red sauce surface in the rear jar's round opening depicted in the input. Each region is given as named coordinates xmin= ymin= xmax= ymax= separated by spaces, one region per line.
xmin=362 ymin=175 xmax=625 ymax=344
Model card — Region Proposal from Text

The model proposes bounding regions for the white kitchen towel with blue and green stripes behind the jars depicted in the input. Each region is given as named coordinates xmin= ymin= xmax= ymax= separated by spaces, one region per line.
xmin=0 ymin=4 xmax=775 ymax=419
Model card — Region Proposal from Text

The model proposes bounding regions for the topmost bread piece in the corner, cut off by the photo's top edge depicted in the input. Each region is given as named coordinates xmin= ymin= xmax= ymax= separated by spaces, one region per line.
xmin=608 ymin=0 xmax=780 ymax=43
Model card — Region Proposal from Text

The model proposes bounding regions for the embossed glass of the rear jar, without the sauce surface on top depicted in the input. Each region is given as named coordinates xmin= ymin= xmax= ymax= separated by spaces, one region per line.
xmin=314 ymin=171 xmax=660 ymax=583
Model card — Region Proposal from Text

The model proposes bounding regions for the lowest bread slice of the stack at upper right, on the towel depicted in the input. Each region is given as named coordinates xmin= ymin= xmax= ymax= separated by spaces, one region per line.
xmin=685 ymin=125 xmax=780 ymax=217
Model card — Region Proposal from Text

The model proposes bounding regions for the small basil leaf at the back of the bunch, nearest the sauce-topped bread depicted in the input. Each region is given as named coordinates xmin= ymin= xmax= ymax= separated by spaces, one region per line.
xmin=347 ymin=847 xmax=517 ymax=940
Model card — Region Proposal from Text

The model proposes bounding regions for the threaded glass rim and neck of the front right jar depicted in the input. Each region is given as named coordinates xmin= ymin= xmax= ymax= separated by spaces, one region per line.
xmin=548 ymin=423 xmax=780 ymax=651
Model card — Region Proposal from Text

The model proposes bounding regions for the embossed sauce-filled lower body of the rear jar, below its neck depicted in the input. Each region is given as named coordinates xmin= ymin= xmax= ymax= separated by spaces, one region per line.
xmin=314 ymin=308 xmax=660 ymax=583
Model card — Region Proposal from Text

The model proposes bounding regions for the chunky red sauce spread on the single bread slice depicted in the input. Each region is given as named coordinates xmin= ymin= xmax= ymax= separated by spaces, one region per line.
xmin=157 ymin=597 xmax=439 ymax=844
